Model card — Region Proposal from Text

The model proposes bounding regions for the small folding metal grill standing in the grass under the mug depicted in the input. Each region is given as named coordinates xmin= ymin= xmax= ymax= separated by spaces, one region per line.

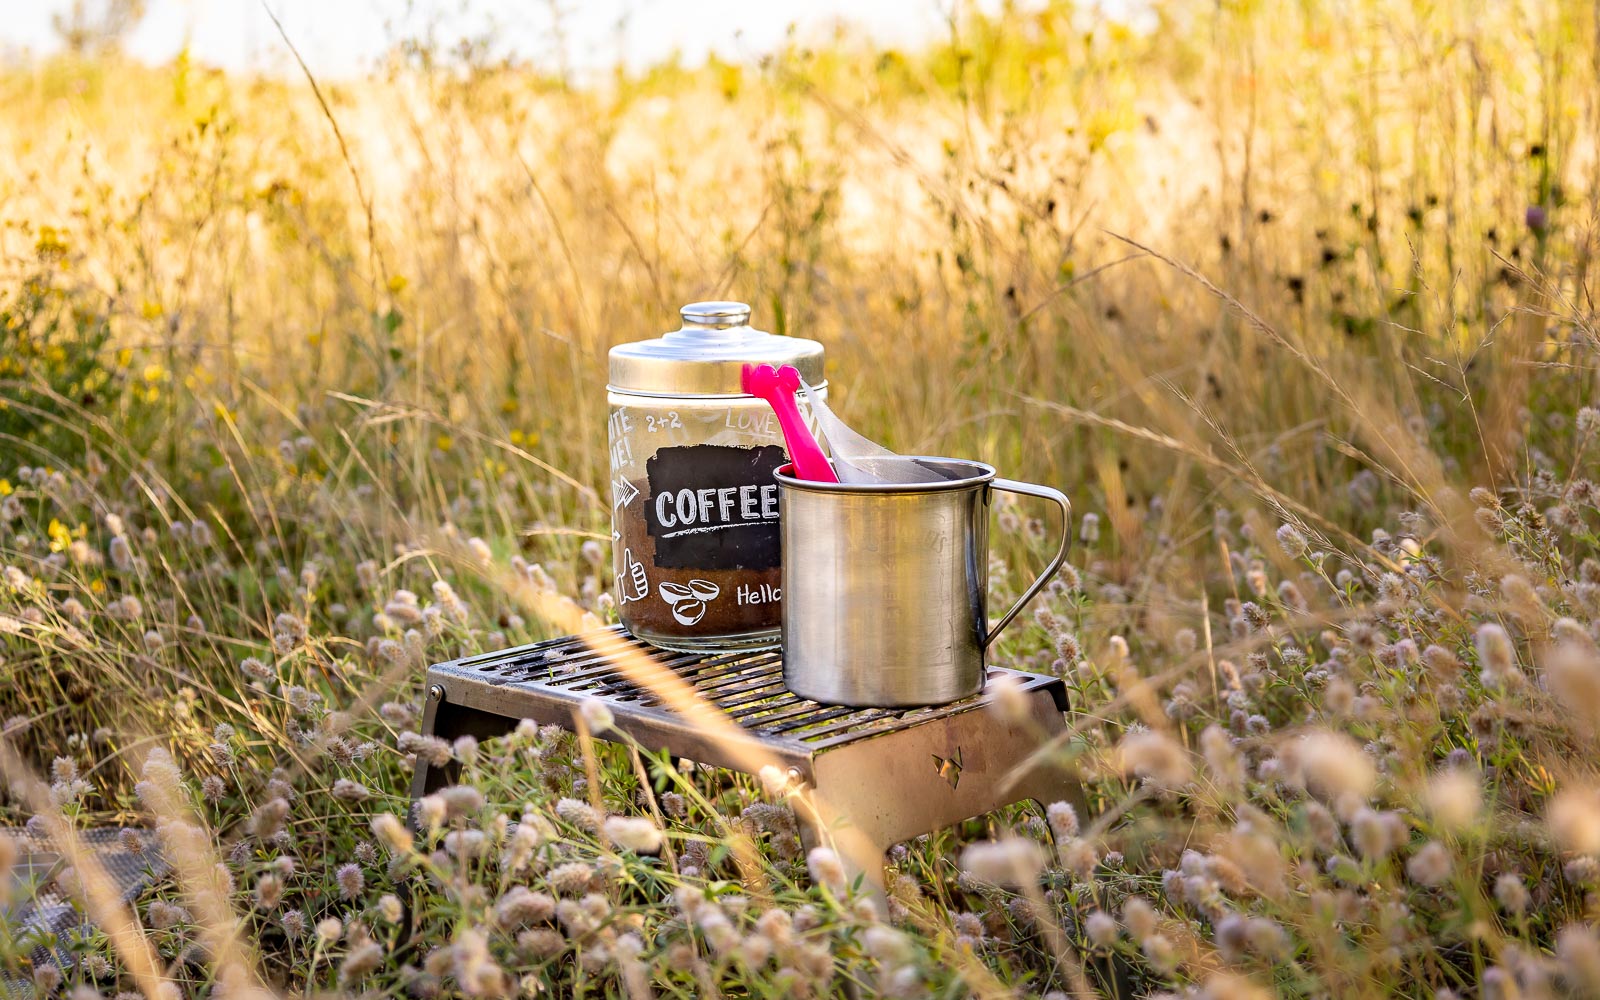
xmin=411 ymin=627 xmax=1080 ymax=882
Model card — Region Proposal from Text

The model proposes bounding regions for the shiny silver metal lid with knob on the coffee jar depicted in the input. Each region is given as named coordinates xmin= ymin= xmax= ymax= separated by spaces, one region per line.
xmin=608 ymin=302 xmax=826 ymax=395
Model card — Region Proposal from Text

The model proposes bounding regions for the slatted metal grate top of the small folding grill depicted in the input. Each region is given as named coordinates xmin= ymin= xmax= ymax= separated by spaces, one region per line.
xmin=430 ymin=626 xmax=1066 ymax=755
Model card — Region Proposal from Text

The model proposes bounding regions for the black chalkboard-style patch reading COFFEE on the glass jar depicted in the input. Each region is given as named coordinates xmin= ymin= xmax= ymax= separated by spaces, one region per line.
xmin=645 ymin=445 xmax=789 ymax=570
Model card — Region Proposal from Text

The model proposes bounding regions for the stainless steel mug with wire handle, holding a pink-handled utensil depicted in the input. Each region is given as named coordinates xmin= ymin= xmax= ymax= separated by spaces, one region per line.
xmin=774 ymin=458 xmax=1072 ymax=707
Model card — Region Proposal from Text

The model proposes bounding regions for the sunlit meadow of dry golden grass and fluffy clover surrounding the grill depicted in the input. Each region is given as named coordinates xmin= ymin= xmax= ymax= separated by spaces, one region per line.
xmin=0 ymin=0 xmax=1600 ymax=1000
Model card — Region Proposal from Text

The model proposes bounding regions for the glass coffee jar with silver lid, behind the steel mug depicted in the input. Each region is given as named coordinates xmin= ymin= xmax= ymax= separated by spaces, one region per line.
xmin=606 ymin=302 xmax=827 ymax=651
